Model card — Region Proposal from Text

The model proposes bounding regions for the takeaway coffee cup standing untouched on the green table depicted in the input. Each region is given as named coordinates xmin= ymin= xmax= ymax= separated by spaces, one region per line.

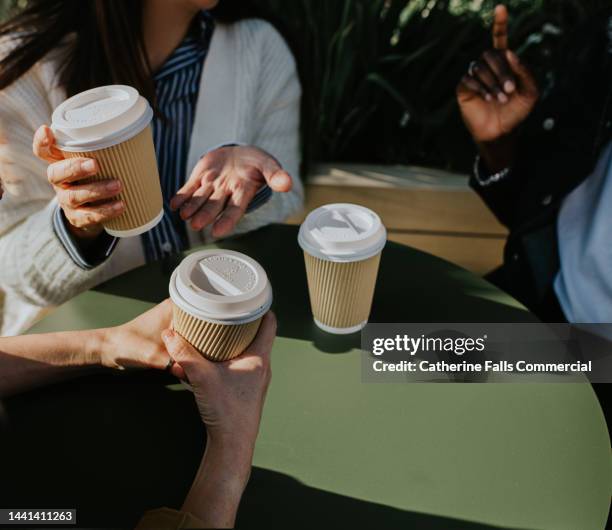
xmin=298 ymin=204 xmax=387 ymax=335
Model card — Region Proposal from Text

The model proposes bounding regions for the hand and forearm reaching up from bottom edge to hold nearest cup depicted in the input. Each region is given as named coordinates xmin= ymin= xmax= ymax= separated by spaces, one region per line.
xmin=163 ymin=313 xmax=276 ymax=528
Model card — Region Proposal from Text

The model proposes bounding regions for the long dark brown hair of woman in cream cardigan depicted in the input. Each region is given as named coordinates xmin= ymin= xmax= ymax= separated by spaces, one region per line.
xmin=0 ymin=0 xmax=263 ymax=103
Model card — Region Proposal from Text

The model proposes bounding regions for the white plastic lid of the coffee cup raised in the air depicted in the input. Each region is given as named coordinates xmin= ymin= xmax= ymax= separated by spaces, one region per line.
xmin=51 ymin=85 xmax=153 ymax=151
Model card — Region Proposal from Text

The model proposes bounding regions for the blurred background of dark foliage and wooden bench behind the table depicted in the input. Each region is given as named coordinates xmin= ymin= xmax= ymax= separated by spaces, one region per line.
xmin=0 ymin=0 xmax=611 ymax=273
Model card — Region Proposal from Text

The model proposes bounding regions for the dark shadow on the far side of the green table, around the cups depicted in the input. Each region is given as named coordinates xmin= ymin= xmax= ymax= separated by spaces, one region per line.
xmin=97 ymin=225 xmax=536 ymax=353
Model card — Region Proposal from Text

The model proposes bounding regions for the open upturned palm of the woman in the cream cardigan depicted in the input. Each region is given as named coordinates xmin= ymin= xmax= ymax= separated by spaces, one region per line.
xmin=170 ymin=147 xmax=293 ymax=237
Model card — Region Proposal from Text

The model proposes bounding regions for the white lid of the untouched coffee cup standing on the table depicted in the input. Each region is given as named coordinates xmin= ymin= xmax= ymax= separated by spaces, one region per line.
xmin=298 ymin=204 xmax=387 ymax=262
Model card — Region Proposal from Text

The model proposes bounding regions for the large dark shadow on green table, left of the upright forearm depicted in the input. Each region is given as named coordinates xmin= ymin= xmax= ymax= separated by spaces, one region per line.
xmin=0 ymin=372 xmax=206 ymax=528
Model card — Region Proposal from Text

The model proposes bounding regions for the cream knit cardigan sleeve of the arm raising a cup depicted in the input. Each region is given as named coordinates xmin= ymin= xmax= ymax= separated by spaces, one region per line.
xmin=0 ymin=67 xmax=106 ymax=310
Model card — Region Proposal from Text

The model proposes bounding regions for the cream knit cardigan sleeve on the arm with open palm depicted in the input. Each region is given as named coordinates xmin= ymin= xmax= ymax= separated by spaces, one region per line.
xmin=230 ymin=20 xmax=304 ymax=233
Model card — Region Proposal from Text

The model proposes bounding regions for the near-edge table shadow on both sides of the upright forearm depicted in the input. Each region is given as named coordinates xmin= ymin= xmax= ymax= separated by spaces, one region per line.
xmin=0 ymin=372 xmax=528 ymax=530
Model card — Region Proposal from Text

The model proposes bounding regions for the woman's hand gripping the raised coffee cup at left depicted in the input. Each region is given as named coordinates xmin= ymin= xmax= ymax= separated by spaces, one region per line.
xmin=33 ymin=125 xmax=125 ymax=240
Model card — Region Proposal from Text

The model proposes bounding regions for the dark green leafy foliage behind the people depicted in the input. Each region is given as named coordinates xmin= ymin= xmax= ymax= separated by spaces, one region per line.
xmin=0 ymin=0 xmax=610 ymax=171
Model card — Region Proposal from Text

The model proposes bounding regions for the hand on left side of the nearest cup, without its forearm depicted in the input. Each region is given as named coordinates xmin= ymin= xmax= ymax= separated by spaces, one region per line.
xmin=99 ymin=300 xmax=185 ymax=378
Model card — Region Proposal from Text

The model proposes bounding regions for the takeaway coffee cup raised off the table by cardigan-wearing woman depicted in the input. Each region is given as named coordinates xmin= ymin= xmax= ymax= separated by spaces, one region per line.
xmin=51 ymin=85 xmax=163 ymax=237
